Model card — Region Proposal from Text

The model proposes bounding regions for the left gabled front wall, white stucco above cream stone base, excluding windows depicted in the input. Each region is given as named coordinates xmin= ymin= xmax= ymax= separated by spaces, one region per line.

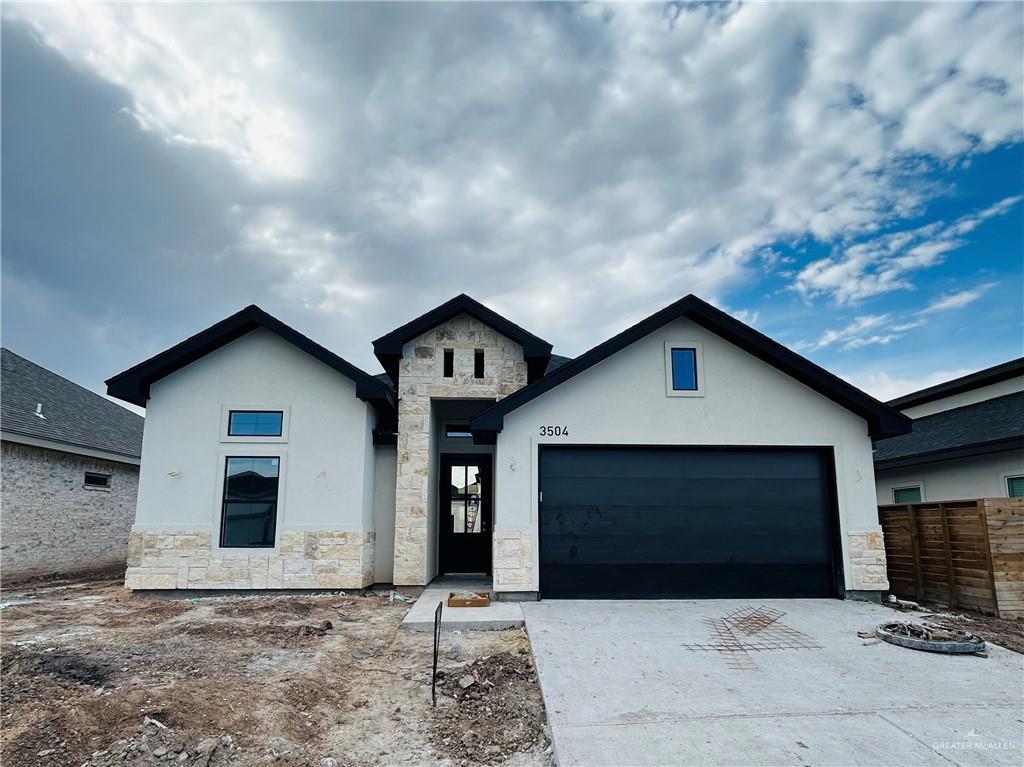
xmin=128 ymin=330 xmax=385 ymax=588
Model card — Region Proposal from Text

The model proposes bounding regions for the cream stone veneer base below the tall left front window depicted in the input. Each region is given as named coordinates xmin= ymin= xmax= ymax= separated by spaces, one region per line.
xmin=125 ymin=530 xmax=374 ymax=590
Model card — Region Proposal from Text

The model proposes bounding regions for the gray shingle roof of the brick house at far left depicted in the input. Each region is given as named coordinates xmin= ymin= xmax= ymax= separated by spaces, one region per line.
xmin=0 ymin=349 xmax=145 ymax=459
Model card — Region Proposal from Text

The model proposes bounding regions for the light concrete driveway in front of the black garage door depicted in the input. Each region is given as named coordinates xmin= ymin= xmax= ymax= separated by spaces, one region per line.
xmin=523 ymin=600 xmax=1024 ymax=767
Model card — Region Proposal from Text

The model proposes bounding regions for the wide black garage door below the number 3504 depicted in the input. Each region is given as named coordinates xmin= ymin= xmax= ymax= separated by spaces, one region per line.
xmin=540 ymin=448 xmax=838 ymax=599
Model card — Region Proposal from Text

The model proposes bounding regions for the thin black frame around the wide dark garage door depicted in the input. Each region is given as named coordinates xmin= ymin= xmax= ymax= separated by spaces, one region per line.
xmin=536 ymin=442 xmax=846 ymax=599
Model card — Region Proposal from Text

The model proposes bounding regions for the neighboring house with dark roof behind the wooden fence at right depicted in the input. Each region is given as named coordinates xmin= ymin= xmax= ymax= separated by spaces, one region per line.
xmin=874 ymin=357 xmax=1024 ymax=505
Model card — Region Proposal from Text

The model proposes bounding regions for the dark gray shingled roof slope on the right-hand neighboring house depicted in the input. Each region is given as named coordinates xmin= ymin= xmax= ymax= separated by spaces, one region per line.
xmin=874 ymin=392 xmax=1024 ymax=463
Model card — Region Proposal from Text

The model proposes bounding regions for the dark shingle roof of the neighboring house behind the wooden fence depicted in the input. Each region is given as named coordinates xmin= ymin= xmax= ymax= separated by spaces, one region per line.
xmin=874 ymin=391 xmax=1024 ymax=469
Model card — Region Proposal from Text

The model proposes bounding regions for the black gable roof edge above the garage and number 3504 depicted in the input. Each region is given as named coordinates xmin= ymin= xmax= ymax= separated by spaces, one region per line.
xmin=471 ymin=294 xmax=910 ymax=442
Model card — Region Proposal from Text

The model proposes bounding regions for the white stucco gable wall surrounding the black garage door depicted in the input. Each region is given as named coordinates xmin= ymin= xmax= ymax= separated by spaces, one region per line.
xmin=495 ymin=319 xmax=885 ymax=591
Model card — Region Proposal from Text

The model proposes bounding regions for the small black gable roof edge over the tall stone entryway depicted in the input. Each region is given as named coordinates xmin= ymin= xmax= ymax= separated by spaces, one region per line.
xmin=374 ymin=293 xmax=551 ymax=383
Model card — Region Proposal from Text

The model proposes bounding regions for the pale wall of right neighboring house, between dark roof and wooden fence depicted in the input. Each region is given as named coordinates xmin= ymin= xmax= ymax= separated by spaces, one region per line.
xmin=874 ymin=451 xmax=1024 ymax=506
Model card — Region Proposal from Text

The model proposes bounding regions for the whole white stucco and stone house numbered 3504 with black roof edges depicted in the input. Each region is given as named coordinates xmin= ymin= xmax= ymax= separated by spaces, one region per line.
xmin=108 ymin=295 xmax=910 ymax=598
